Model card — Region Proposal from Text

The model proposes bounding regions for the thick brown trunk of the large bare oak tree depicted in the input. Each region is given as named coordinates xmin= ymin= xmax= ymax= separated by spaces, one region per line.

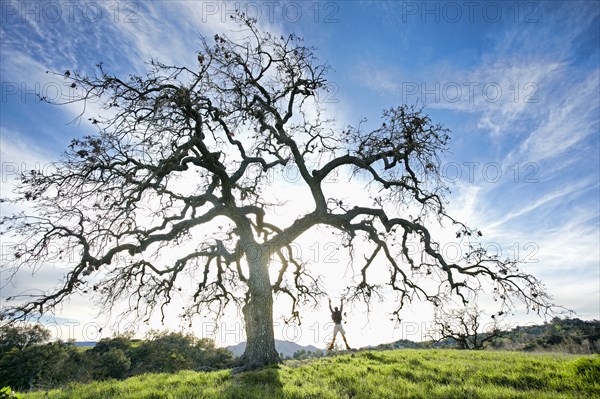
xmin=234 ymin=245 xmax=281 ymax=372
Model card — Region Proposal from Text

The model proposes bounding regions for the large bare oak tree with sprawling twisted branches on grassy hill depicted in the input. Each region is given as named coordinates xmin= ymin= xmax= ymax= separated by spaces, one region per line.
xmin=2 ymin=15 xmax=549 ymax=370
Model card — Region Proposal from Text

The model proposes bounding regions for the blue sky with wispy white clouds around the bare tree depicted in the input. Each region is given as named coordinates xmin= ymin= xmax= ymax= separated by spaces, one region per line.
xmin=0 ymin=1 xmax=600 ymax=345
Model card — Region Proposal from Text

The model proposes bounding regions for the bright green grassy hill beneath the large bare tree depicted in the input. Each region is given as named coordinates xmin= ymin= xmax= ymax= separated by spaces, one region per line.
xmin=14 ymin=349 xmax=600 ymax=399
